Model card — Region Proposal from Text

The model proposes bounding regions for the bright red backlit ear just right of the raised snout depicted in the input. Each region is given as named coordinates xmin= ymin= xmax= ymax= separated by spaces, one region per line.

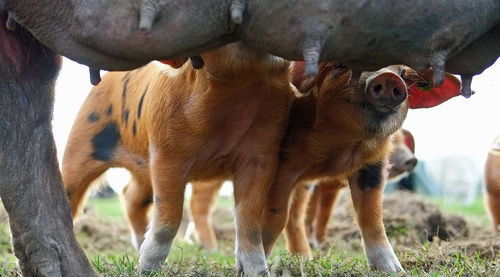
xmin=408 ymin=73 xmax=461 ymax=109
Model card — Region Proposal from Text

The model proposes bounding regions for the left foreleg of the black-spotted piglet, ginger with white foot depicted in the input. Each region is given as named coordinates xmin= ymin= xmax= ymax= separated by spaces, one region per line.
xmin=138 ymin=153 xmax=188 ymax=273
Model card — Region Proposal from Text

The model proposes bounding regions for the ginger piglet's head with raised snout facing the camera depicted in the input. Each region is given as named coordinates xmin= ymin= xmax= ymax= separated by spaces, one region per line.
xmin=290 ymin=62 xmax=408 ymax=138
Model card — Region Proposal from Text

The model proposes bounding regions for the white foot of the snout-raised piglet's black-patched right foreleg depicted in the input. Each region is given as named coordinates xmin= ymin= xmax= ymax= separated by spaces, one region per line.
xmin=365 ymin=246 xmax=404 ymax=273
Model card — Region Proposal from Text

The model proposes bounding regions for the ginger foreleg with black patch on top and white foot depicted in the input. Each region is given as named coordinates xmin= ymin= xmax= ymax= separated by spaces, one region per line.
xmin=349 ymin=161 xmax=403 ymax=272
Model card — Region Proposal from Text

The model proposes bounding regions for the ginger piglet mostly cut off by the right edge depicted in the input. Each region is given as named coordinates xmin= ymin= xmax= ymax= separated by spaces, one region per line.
xmin=484 ymin=136 xmax=500 ymax=231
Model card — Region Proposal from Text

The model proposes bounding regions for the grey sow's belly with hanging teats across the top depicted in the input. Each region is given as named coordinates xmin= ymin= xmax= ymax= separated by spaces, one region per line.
xmin=4 ymin=0 xmax=500 ymax=96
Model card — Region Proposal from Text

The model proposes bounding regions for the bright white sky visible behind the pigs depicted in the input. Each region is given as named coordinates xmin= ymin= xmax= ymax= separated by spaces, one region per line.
xmin=52 ymin=58 xmax=500 ymax=198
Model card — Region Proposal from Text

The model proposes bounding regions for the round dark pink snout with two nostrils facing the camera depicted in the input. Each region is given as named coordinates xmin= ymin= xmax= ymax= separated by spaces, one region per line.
xmin=365 ymin=72 xmax=407 ymax=108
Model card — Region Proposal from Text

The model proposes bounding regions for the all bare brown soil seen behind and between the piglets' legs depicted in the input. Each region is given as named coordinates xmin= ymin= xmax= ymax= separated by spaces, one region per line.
xmin=0 ymin=191 xmax=500 ymax=272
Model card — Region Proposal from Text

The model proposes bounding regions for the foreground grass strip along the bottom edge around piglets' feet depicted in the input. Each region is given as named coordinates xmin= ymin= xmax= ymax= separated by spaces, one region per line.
xmin=86 ymin=244 xmax=500 ymax=277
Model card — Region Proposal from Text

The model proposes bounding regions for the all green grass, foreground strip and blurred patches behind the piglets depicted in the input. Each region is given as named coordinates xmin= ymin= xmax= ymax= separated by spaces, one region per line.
xmin=0 ymin=193 xmax=500 ymax=277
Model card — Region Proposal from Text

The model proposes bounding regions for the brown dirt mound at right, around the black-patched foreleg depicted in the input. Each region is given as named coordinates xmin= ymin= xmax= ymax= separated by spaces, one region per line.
xmin=320 ymin=191 xmax=500 ymax=258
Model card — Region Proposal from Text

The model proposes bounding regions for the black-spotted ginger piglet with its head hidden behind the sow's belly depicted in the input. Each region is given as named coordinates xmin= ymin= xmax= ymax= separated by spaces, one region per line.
xmin=62 ymin=43 xmax=293 ymax=275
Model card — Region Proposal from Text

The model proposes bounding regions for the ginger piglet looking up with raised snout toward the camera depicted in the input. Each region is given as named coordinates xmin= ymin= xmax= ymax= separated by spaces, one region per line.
xmin=262 ymin=63 xmax=416 ymax=272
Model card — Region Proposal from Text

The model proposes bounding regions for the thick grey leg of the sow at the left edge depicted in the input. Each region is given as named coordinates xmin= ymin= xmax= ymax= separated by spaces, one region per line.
xmin=0 ymin=10 xmax=95 ymax=276
